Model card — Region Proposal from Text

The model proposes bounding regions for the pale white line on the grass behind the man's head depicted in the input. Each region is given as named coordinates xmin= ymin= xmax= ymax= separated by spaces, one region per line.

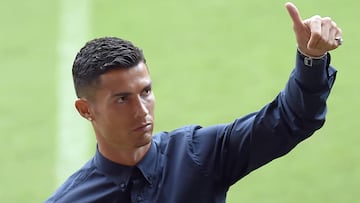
xmin=56 ymin=0 xmax=91 ymax=185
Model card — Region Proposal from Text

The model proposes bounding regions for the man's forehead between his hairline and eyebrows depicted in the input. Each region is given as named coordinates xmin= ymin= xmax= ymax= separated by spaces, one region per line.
xmin=98 ymin=62 xmax=151 ymax=91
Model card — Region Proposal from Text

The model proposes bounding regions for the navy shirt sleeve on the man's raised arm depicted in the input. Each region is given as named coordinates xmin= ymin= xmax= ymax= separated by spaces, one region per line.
xmin=190 ymin=52 xmax=336 ymax=186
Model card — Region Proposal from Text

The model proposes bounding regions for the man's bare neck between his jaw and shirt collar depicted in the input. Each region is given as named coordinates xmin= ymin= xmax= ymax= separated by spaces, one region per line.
xmin=98 ymin=142 xmax=151 ymax=166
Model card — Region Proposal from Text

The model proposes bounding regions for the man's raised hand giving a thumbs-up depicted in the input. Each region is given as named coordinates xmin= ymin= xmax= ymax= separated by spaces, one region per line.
xmin=285 ymin=2 xmax=342 ymax=57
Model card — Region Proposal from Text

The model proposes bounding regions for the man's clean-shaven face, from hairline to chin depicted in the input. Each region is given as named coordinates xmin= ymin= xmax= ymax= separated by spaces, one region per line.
xmin=89 ymin=62 xmax=155 ymax=150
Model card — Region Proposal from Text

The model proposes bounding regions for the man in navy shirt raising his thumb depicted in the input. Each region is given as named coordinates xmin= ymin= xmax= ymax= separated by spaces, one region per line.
xmin=47 ymin=3 xmax=342 ymax=203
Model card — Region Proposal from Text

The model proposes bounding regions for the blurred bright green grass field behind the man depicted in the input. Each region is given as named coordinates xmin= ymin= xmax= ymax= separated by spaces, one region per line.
xmin=0 ymin=0 xmax=360 ymax=203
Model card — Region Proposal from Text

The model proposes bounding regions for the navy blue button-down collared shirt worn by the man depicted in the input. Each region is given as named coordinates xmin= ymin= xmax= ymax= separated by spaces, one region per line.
xmin=46 ymin=53 xmax=336 ymax=203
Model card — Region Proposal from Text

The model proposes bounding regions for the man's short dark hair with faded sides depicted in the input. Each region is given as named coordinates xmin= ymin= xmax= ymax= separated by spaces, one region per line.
xmin=72 ymin=37 xmax=146 ymax=98
